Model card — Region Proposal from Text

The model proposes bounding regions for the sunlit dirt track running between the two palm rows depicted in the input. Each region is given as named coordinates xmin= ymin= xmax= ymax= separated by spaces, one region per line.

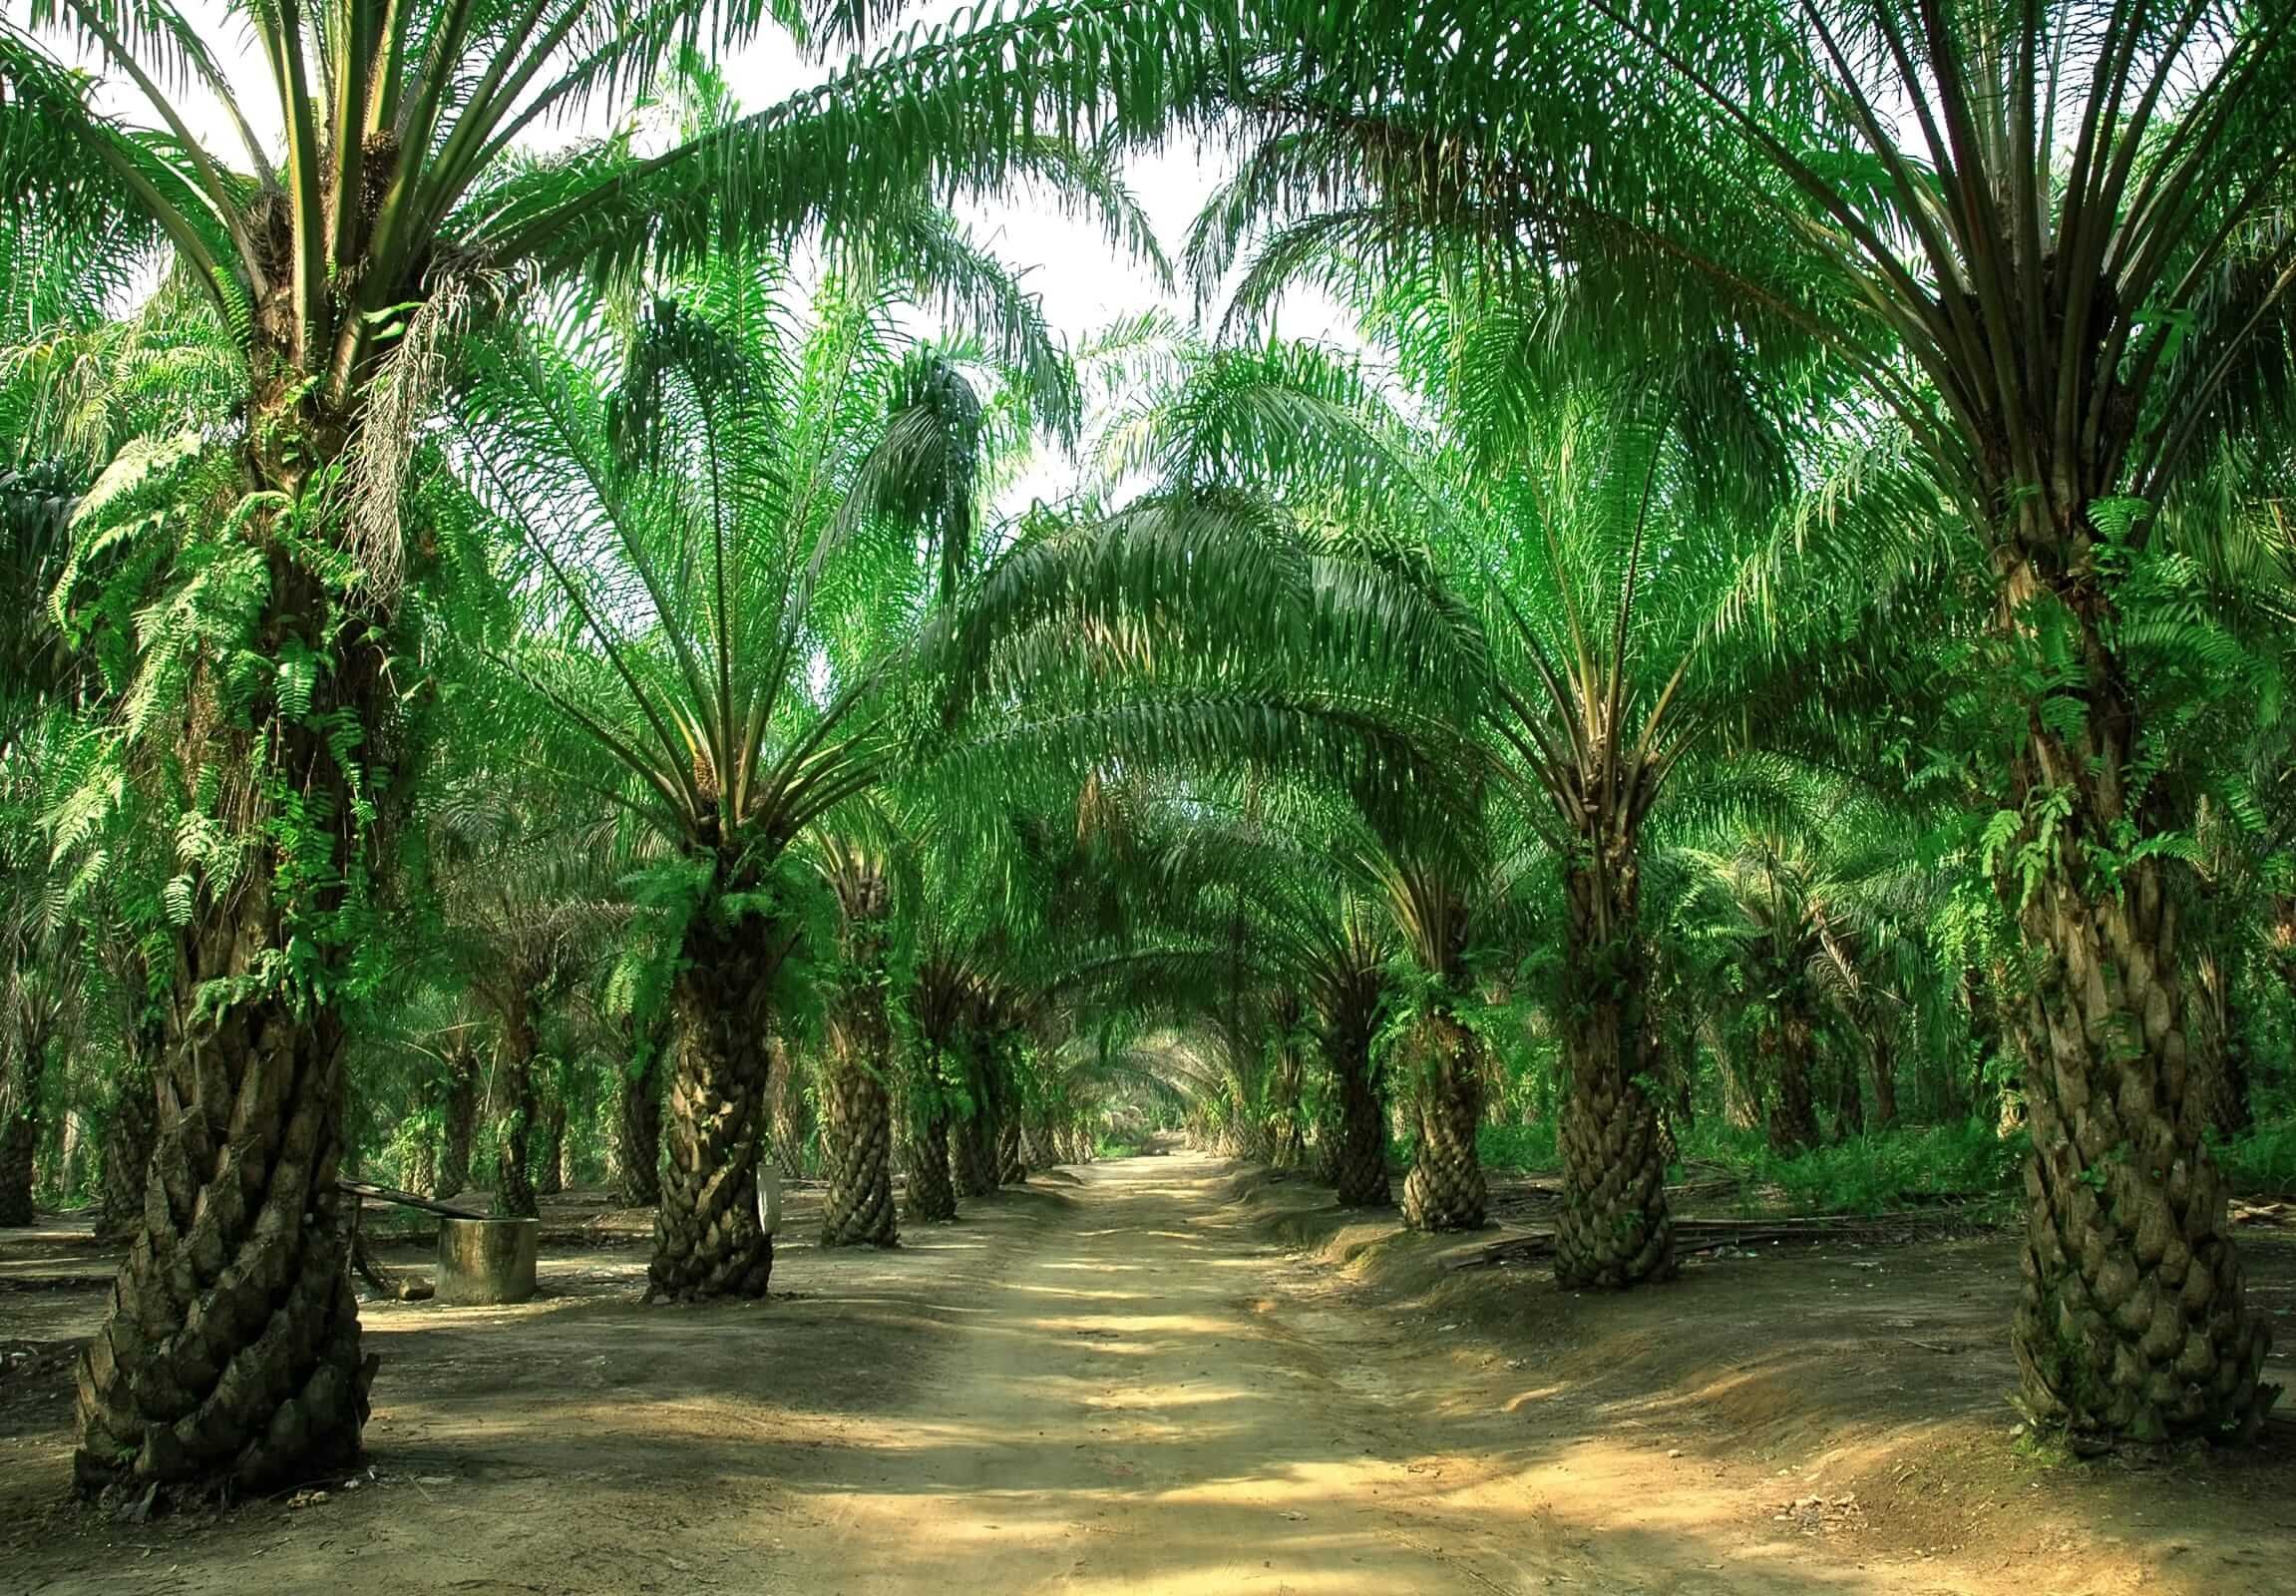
xmin=776 ymin=1155 xmax=1993 ymax=1596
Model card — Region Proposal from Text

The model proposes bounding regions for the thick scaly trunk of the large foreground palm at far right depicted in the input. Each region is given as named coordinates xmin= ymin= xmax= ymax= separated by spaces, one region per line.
xmin=1995 ymin=505 xmax=2278 ymax=1444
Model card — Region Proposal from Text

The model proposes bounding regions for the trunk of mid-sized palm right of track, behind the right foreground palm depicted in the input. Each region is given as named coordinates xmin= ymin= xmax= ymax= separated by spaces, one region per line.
xmin=1554 ymin=859 xmax=1676 ymax=1291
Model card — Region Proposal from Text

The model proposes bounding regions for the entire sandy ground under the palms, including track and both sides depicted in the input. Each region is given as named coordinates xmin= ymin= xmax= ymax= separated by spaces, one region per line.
xmin=0 ymin=1155 xmax=2296 ymax=1596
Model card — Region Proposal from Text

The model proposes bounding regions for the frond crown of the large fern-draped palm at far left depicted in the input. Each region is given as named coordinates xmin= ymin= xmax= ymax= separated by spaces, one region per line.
xmin=0 ymin=0 xmax=1153 ymax=371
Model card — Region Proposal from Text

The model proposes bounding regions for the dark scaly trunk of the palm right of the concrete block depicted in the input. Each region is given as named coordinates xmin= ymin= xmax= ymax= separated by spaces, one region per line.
xmin=645 ymin=917 xmax=776 ymax=1302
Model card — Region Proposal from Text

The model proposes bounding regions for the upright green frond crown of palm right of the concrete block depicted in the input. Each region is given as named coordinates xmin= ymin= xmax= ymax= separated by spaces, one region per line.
xmin=452 ymin=234 xmax=1063 ymax=882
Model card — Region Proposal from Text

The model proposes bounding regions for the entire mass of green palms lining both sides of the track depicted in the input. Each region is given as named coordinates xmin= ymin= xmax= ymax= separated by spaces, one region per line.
xmin=0 ymin=0 xmax=2296 ymax=1495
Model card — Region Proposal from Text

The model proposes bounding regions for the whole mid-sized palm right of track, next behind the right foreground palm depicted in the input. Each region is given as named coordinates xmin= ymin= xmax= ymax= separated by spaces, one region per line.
xmin=1083 ymin=332 xmax=1809 ymax=1286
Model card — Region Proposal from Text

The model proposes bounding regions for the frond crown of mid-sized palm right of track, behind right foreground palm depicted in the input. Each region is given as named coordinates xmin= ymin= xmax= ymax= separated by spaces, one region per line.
xmin=1047 ymin=323 xmax=1844 ymax=872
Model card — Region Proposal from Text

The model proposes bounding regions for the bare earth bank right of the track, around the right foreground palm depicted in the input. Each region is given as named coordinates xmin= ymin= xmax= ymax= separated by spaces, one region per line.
xmin=1231 ymin=1173 xmax=2296 ymax=1596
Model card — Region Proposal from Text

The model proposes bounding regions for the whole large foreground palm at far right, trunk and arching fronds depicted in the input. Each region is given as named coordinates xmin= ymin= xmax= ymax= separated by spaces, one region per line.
xmin=1166 ymin=0 xmax=2296 ymax=1439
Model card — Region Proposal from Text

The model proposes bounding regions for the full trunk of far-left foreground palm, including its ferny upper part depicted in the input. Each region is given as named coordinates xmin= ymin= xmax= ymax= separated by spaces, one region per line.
xmin=74 ymin=519 xmax=397 ymax=1497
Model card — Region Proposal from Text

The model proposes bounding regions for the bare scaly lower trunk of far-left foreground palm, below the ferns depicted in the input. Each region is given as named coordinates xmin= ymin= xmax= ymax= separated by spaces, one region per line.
xmin=74 ymin=909 xmax=377 ymax=1497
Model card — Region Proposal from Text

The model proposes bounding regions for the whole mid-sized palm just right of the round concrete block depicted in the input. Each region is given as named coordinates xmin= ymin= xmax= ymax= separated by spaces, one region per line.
xmin=459 ymin=239 xmax=1065 ymax=1298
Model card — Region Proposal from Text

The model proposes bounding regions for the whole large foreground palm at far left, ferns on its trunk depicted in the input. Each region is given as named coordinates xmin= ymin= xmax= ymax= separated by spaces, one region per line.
xmin=0 ymin=0 xmax=1166 ymax=1490
